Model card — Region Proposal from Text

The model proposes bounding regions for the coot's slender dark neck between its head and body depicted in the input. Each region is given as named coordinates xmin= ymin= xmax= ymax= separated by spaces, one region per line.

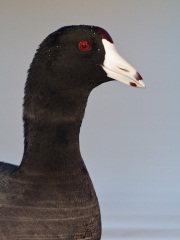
xmin=20 ymin=85 xmax=89 ymax=175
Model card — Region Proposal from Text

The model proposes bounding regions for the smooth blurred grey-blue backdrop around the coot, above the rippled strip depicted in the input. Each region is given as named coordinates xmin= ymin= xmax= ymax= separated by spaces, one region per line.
xmin=0 ymin=0 xmax=180 ymax=239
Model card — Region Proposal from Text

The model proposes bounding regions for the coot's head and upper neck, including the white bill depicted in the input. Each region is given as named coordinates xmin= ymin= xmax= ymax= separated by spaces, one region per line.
xmin=24 ymin=25 xmax=144 ymax=124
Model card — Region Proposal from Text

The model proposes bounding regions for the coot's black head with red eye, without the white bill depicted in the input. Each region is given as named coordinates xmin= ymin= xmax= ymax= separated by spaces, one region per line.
xmin=29 ymin=25 xmax=112 ymax=90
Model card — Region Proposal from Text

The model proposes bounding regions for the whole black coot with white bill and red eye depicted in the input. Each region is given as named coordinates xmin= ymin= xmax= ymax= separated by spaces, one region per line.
xmin=0 ymin=25 xmax=145 ymax=240
